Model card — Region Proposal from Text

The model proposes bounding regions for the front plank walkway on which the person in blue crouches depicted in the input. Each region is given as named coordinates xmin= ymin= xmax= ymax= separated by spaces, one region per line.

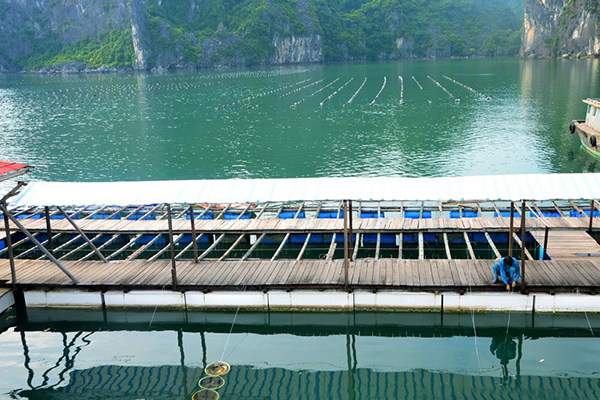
xmin=0 ymin=258 xmax=600 ymax=293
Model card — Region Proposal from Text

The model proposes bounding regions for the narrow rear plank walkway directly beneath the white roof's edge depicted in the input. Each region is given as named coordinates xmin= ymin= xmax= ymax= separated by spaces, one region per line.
xmin=2 ymin=217 xmax=598 ymax=235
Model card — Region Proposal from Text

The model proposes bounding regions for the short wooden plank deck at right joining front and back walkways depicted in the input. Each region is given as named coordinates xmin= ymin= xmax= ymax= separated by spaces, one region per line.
xmin=531 ymin=230 xmax=600 ymax=260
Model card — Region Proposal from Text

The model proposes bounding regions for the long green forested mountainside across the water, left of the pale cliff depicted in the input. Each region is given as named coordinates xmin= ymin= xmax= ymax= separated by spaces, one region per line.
xmin=0 ymin=0 xmax=523 ymax=71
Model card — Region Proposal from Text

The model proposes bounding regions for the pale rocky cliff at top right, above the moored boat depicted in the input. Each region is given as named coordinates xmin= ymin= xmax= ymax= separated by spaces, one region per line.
xmin=521 ymin=0 xmax=600 ymax=58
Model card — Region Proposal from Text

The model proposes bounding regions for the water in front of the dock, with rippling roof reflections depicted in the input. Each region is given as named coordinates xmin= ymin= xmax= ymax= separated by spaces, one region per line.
xmin=0 ymin=309 xmax=600 ymax=400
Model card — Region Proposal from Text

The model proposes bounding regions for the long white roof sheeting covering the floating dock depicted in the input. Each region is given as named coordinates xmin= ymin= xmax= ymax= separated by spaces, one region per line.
xmin=11 ymin=173 xmax=600 ymax=207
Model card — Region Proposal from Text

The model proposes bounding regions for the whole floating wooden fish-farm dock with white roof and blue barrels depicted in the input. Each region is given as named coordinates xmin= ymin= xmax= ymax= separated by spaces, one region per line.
xmin=0 ymin=174 xmax=600 ymax=312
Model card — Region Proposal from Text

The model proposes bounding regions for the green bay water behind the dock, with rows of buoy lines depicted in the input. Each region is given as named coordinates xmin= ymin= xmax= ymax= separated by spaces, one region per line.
xmin=0 ymin=59 xmax=600 ymax=180
